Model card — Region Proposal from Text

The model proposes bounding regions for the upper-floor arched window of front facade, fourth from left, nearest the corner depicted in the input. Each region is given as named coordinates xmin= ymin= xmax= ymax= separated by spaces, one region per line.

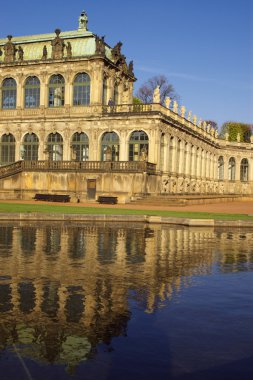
xmin=73 ymin=73 xmax=90 ymax=106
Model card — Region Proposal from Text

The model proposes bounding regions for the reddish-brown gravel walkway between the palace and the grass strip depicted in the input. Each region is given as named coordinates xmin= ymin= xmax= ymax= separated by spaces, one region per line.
xmin=0 ymin=200 xmax=253 ymax=215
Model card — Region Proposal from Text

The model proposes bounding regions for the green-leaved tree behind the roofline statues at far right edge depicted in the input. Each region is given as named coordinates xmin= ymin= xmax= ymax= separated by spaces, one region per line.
xmin=220 ymin=121 xmax=253 ymax=142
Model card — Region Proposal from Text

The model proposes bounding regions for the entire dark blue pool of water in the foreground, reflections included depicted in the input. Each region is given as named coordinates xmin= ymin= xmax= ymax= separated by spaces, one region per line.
xmin=0 ymin=222 xmax=253 ymax=380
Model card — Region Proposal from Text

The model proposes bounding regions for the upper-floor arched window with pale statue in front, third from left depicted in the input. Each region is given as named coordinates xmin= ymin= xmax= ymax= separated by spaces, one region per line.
xmin=48 ymin=74 xmax=65 ymax=107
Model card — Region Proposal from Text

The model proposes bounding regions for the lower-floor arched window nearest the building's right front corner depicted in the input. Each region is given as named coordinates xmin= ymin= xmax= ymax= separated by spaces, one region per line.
xmin=129 ymin=131 xmax=149 ymax=161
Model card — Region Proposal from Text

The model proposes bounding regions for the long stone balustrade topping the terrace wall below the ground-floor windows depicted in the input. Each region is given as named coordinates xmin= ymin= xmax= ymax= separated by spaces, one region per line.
xmin=0 ymin=161 xmax=156 ymax=178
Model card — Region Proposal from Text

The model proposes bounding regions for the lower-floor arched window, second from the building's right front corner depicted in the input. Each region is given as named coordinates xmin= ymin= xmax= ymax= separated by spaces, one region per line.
xmin=101 ymin=132 xmax=119 ymax=161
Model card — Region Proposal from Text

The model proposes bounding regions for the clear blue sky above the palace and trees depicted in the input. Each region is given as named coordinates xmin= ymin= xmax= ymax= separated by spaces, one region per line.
xmin=0 ymin=0 xmax=253 ymax=125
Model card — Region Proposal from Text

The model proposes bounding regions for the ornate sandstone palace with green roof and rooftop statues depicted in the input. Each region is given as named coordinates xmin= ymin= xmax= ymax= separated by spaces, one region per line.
xmin=0 ymin=12 xmax=253 ymax=203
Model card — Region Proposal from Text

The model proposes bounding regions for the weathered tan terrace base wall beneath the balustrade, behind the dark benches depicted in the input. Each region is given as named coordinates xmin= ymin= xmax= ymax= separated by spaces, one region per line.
xmin=0 ymin=171 xmax=160 ymax=203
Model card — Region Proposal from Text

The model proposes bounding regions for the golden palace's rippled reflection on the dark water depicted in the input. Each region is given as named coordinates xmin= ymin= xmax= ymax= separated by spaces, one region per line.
xmin=0 ymin=223 xmax=253 ymax=370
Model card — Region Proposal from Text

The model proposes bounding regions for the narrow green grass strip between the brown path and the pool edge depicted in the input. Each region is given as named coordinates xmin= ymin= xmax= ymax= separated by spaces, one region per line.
xmin=0 ymin=203 xmax=253 ymax=220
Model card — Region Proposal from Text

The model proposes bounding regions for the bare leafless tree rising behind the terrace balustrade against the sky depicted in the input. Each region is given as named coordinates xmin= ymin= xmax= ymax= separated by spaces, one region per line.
xmin=135 ymin=75 xmax=178 ymax=104
